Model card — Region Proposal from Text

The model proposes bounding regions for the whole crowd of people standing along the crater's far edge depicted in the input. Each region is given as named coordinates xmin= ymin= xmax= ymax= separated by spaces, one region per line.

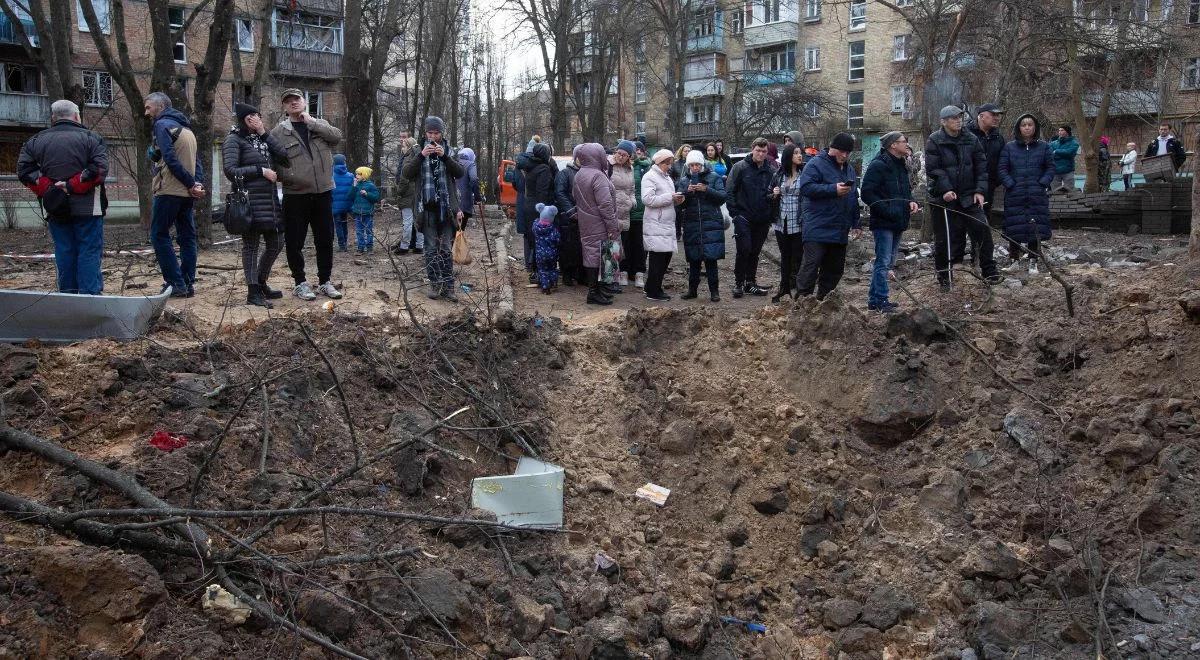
xmin=18 ymin=96 xmax=1186 ymax=312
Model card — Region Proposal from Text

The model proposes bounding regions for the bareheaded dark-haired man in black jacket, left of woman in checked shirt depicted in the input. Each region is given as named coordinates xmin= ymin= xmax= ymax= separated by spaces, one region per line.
xmin=725 ymin=138 xmax=775 ymax=298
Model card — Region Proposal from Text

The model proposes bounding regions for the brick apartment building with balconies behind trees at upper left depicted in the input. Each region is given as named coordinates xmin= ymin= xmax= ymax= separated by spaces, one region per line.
xmin=0 ymin=0 xmax=346 ymax=222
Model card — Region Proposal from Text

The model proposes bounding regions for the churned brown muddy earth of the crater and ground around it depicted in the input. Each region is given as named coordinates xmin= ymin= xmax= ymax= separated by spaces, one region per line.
xmin=0 ymin=210 xmax=1200 ymax=659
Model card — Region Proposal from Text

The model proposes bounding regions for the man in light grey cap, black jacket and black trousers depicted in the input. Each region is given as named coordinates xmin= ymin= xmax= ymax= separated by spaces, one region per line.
xmin=925 ymin=106 xmax=1003 ymax=290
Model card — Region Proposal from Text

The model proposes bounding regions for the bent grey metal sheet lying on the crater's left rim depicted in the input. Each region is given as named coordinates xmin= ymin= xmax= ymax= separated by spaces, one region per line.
xmin=0 ymin=288 xmax=170 ymax=343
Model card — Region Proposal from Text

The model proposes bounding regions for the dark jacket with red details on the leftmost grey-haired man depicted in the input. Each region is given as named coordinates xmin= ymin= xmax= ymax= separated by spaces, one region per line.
xmin=17 ymin=119 xmax=108 ymax=218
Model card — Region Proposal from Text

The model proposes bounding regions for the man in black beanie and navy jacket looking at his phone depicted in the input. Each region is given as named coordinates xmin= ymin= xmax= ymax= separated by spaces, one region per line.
xmin=796 ymin=133 xmax=863 ymax=300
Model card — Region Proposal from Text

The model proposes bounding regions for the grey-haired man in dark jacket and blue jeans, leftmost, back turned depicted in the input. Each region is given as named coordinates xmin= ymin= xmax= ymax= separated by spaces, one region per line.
xmin=17 ymin=100 xmax=108 ymax=295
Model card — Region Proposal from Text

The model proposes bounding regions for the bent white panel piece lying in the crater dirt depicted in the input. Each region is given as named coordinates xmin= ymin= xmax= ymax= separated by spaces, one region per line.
xmin=470 ymin=457 xmax=566 ymax=529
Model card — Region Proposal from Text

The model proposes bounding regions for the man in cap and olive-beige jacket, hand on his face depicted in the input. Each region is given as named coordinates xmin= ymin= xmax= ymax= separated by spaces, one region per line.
xmin=271 ymin=89 xmax=342 ymax=300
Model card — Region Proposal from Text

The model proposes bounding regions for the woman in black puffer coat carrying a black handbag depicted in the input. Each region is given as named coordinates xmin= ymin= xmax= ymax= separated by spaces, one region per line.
xmin=221 ymin=103 xmax=288 ymax=307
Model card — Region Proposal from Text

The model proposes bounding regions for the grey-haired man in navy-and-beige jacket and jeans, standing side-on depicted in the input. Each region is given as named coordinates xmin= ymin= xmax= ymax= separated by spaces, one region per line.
xmin=145 ymin=91 xmax=205 ymax=298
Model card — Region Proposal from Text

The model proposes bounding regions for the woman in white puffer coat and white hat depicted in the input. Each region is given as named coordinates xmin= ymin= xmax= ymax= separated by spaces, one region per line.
xmin=642 ymin=149 xmax=683 ymax=302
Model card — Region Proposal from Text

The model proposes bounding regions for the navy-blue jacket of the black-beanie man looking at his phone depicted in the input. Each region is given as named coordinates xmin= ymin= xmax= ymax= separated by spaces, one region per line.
xmin=799 ymin=151 xmax=858 ymax=245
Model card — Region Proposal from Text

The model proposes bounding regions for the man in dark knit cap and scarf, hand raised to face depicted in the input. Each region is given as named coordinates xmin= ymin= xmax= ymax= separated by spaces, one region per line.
xmin=400 ymin=115 xmax=463 ymax=302
